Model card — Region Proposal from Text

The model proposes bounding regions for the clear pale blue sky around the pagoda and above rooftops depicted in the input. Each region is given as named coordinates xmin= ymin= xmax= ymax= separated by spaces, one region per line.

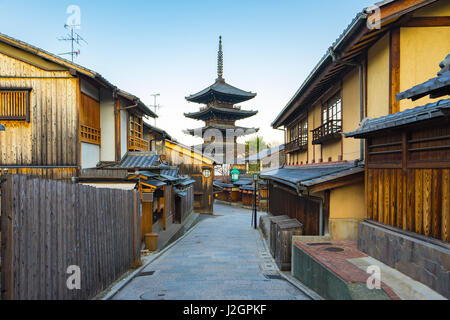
xmin=0 ymin=0 xmax=373 ymax=144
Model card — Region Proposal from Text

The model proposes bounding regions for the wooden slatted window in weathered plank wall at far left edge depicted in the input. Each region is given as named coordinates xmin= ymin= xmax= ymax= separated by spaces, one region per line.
xmin=0 ymin=89 xmax=31 ymax=122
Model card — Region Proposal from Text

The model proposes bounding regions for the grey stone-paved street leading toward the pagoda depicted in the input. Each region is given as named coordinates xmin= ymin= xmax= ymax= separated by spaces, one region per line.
xmin=114 ymin=205 xmax=309 ymax=300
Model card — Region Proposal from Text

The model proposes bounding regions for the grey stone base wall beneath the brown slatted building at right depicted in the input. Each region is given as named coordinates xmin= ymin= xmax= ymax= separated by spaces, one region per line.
xmin=358 ymin=222 xmax=450 ymax=299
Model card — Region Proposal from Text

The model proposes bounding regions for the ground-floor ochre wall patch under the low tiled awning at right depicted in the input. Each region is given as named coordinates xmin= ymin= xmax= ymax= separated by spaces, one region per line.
xmin=329 ymin=182 xmax=365 ymax=240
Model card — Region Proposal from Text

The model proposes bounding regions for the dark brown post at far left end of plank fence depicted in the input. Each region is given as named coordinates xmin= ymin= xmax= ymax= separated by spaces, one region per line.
xmin=0 ymin=175 xmax=15 ymax=300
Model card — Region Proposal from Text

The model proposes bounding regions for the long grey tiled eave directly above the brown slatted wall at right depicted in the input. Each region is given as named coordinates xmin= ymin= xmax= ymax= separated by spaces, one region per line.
xmin=345 ymin=99 xmax=450 ymax=138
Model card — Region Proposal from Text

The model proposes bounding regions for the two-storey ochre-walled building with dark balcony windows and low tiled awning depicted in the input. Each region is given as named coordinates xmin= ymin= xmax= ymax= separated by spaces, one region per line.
xmin=262 ymin=0 xmax=450 ymax=240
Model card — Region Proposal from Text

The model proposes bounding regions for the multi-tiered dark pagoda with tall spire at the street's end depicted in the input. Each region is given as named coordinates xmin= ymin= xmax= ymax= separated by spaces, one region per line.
xmin=185 ymin=37 xmax=258 ymax=164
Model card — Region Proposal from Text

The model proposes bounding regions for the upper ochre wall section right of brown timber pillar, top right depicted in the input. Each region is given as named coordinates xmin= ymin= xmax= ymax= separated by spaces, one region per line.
xmin=400 ymin=26 xmax=450 ymax=111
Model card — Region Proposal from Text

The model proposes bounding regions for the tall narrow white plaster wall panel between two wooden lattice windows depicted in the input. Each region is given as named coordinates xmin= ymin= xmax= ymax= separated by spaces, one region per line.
xmin=100 ymin=89 xmax=116 ymax=161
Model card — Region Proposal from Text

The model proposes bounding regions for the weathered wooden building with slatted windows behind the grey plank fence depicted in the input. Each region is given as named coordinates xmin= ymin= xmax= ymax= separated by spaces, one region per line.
xmin=0 ymin=34 xmax=157 ymax=179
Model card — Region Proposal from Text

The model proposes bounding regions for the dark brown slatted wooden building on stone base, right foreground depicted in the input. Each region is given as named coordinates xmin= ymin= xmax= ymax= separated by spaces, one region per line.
xmin=346 ymin=55 xmax=450 ymax=298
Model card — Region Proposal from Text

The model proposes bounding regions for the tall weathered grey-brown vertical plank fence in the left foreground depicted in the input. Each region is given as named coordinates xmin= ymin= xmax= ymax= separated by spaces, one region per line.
xmin=0 ymin=175 xmax=140 ymax=300
